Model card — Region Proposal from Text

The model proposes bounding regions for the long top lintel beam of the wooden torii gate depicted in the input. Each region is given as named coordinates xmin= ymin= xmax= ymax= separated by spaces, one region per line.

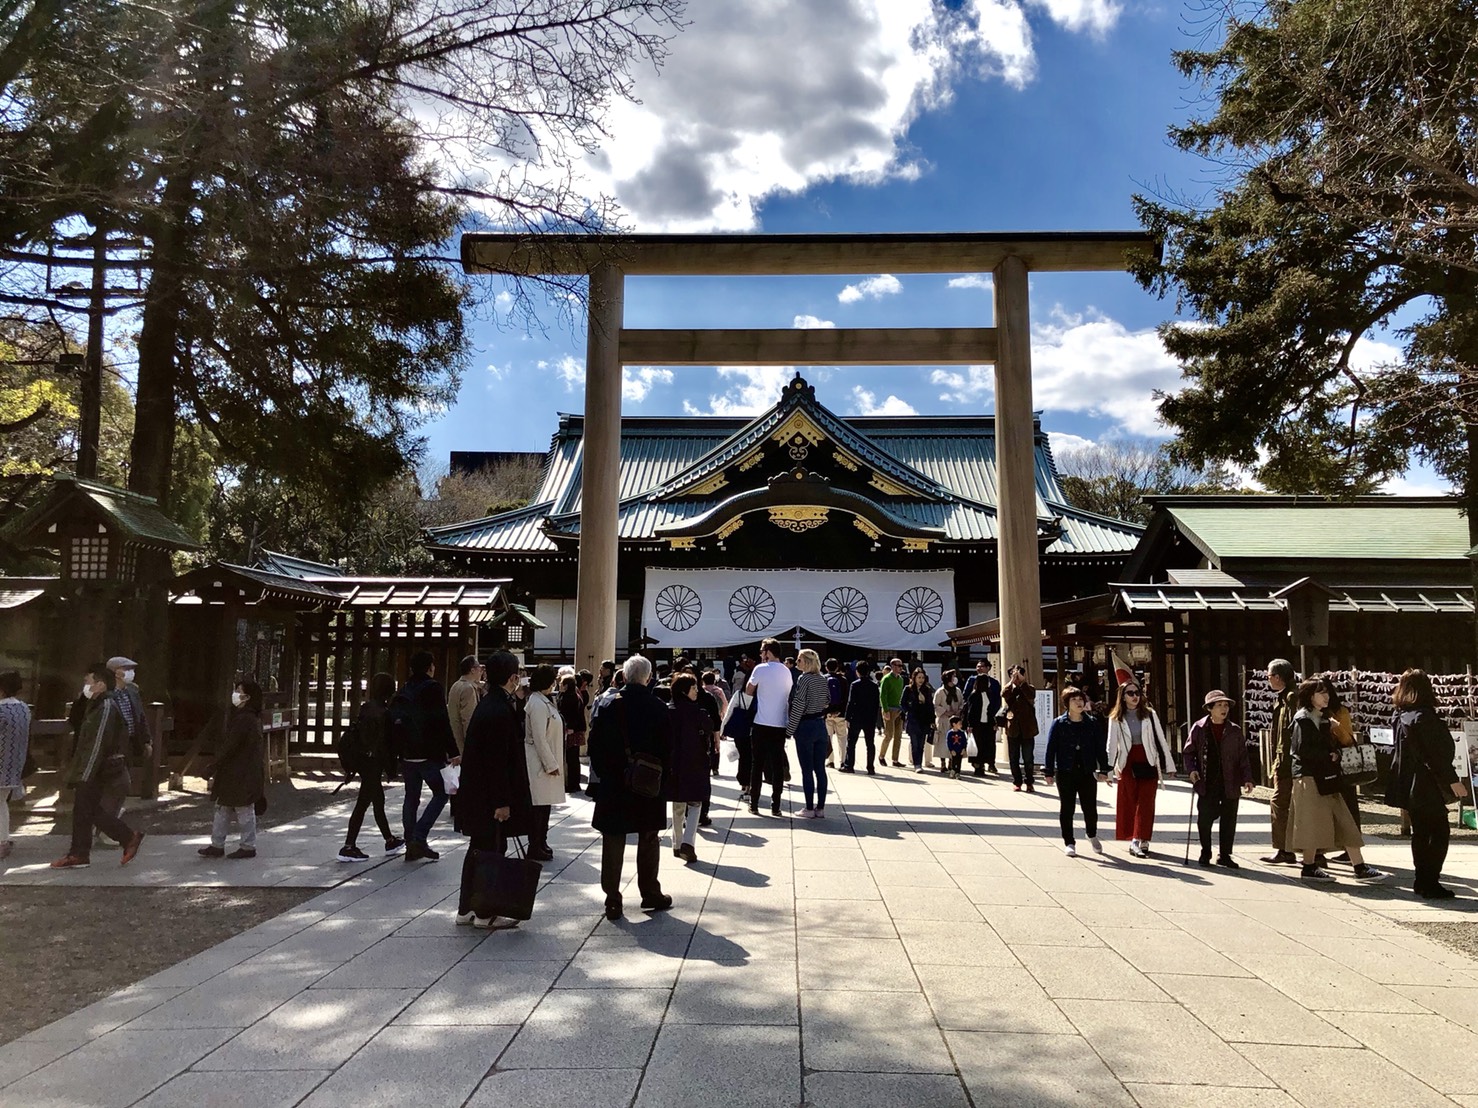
xmin=461 ymin=230 xmax=1160 ymax=276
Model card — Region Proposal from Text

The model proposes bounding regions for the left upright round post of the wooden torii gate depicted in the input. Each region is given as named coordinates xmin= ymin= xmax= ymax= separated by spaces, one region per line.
xmin=575 ymin=261 xmax=625 ymax=672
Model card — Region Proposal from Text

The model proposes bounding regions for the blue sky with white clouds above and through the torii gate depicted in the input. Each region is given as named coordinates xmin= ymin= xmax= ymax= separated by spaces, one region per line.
xmin=424 ymin=0 xmax=1431 ymax=490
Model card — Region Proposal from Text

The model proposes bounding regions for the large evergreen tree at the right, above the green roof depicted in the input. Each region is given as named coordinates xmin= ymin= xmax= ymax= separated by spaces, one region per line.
xmin=1135 ymin=0 xmax=1478 ymax=641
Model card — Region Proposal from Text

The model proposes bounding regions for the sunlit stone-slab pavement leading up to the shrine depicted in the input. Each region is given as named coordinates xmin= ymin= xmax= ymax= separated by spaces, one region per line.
xmin=0 ymin=770 xmax=1478 ymax=1108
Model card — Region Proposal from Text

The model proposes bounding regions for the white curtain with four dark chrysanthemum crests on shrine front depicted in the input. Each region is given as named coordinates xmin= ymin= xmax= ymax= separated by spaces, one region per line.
xmin=641 ymin=566 xmax=956 ymax=652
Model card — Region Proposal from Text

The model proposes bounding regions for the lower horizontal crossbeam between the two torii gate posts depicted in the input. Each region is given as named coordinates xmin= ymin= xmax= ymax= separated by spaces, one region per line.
xmin=621 ymin=326 xmax=996 ymax=365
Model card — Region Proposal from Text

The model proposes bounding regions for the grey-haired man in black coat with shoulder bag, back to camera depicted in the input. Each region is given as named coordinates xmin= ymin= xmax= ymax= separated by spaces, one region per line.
xmin=590 ymin=654 xmax=672 ymax=919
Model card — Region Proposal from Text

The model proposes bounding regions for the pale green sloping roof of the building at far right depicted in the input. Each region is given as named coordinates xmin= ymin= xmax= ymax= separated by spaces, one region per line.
xmin=1156 ymin=496 xmax=1472 ymax=563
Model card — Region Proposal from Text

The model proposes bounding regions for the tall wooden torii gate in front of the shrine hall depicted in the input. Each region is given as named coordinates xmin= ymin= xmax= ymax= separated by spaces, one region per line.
xmin=461 ymin=232 xmax=1160 ymax=685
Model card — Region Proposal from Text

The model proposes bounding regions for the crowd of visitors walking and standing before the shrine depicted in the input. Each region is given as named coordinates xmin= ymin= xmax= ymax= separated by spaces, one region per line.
xmin=0 ymin=640 xmax=1468 ymax=910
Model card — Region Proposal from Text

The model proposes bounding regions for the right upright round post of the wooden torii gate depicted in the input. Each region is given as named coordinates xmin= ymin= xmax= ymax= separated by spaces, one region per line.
xmin=993 ymin=256 xmax=1042 ymax=688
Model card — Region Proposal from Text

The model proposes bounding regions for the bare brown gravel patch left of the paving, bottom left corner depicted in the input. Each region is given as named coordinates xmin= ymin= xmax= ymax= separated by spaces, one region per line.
xmin=0 ymin=885 xmax=322 ymax=1043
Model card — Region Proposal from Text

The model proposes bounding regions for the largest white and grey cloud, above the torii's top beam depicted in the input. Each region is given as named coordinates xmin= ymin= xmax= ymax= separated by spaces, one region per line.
xmin=584 ymin=0 xmax=1119 ymax=230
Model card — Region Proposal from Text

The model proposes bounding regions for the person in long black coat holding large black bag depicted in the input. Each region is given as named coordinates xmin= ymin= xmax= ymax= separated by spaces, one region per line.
xmin=457 ymin=650 xmax=535 ymax=931
